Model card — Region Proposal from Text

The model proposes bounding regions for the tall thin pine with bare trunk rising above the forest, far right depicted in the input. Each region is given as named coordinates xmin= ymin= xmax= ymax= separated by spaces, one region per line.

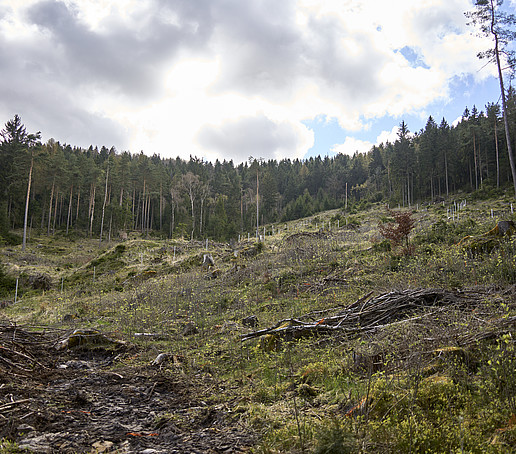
xmin=466 ymin=0 xmax=516 ymax=195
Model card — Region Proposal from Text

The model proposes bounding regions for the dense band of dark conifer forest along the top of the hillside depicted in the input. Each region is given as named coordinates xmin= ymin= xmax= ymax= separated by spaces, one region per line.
xmin=0 ymin=89 xmax=516 ymax=245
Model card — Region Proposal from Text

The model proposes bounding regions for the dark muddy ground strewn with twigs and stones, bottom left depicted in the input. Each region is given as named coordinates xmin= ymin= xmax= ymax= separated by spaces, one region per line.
xmin=0 ymin=323 xmax=256 ymax=454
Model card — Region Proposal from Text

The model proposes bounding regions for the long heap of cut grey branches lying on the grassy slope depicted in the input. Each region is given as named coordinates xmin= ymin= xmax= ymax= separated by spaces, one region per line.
xmin=241 ymin=289 xmax=488 ymax=341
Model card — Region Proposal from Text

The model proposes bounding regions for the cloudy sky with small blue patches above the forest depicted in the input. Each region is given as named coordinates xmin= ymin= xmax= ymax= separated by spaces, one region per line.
xmin=0 ymin=0 xmax=516 ymax=163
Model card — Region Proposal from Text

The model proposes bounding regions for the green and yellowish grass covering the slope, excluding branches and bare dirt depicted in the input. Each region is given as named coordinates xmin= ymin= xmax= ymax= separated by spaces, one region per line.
xmin=2 ymin=198 xmax=516 ymax=454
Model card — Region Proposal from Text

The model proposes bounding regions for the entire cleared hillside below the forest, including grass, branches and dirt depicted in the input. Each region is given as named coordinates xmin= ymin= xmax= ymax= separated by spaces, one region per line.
xmin=0 ymin=196 xmax=516 ymax=453
